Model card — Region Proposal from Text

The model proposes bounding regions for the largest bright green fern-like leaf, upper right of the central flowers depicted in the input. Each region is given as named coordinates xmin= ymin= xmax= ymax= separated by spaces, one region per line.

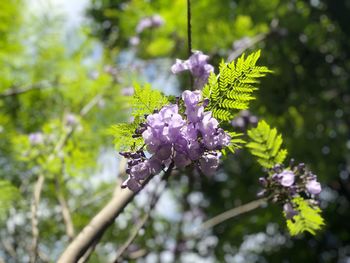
xmin=203 ymin=51 xmax=271 ymax=121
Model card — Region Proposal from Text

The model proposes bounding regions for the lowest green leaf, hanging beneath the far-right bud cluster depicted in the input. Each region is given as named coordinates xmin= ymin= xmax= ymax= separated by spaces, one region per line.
xmin=287 ymin=197 xmax=325 ymax=236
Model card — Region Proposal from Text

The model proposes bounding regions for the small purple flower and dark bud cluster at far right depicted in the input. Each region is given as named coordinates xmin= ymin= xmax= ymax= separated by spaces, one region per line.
xmin=258 ymin=160 xmax=322 ymax=219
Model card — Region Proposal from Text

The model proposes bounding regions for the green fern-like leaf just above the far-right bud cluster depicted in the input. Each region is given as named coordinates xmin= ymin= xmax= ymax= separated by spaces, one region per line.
xmin=246 ymin=121 xmax=287 ymax=168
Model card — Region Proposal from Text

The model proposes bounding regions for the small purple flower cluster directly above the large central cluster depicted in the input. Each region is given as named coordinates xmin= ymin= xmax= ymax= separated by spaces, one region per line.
xmin=171 ymin=51 xmax=214 ymax=89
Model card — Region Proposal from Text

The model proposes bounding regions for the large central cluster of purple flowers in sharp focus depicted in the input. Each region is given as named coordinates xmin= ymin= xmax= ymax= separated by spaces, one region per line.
xmin=121 ymin=90 xmax=231 ymax=191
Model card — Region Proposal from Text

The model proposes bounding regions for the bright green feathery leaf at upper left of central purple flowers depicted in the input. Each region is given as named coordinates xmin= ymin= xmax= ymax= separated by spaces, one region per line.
xmin=132 ymin=85 xmax=169 ymax=120
